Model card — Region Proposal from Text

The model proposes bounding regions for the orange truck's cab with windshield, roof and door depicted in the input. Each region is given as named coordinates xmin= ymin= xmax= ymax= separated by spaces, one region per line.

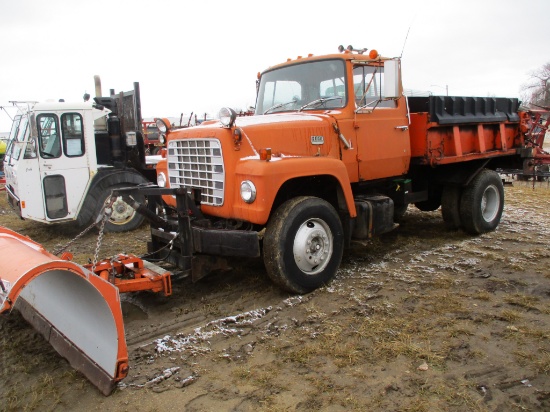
xmin=256 ymin=50 xmax=410 ymax=181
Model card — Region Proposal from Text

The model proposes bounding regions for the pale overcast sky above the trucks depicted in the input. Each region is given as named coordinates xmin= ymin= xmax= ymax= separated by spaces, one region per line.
xmin=0 ymin=0 xmax=550 ymax=132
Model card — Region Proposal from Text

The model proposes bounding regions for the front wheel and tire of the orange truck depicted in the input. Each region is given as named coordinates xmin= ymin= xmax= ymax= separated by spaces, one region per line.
xmin=263 ymin=196 xmax=344 ymax=293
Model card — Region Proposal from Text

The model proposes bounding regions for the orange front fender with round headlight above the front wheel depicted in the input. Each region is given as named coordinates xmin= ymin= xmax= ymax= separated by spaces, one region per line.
xmin=233 ymin=157 xmax=357 ymax=225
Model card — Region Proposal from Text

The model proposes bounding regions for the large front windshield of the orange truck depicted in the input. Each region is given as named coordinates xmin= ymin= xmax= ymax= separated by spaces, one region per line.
xmin=256 ymin=59 xmax=347 ymax=114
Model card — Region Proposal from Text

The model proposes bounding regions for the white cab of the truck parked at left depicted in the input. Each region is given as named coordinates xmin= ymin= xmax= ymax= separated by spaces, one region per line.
xmin=4 ymin=103 xmax=100 ymax=222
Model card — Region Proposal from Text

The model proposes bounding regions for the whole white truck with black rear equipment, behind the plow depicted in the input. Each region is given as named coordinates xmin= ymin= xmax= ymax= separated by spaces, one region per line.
xmin=4 ymin=80 xmax=154 ymax=231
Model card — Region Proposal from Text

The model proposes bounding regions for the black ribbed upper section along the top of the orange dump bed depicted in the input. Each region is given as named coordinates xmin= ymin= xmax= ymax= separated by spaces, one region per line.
xmin=407 ymin=96 xmax=519 ymax=125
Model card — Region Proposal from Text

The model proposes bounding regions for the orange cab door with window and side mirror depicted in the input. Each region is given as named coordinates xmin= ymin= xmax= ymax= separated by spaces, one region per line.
xmin=353 ymin=63 xmax=410 ymax=180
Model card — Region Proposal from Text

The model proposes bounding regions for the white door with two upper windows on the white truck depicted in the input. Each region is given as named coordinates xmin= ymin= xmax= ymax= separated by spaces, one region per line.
xmin=36 ymin=111 xmax=90 ymax=221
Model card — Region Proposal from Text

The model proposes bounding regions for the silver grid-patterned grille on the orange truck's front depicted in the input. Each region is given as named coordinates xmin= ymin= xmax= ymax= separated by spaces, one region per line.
xmin=168 ymin=139 xmax=225 ymax=206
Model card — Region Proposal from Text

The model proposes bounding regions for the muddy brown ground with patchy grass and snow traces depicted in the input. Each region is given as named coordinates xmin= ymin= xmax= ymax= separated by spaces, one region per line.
xmin=0 ymin=182 xmax=550 ymax=411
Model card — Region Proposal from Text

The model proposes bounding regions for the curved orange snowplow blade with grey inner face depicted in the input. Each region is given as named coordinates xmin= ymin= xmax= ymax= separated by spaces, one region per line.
xmin=0 ymin=226 xmax=128 ymax=395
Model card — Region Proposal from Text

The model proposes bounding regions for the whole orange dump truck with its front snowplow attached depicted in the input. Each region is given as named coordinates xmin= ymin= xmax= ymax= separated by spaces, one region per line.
xmin=0 ymin=47 xmax=547 ymax=394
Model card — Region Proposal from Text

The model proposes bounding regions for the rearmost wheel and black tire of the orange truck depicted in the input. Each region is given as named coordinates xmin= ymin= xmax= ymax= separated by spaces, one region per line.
xmin=460 ymin=169 xmax=504 ymax=235
